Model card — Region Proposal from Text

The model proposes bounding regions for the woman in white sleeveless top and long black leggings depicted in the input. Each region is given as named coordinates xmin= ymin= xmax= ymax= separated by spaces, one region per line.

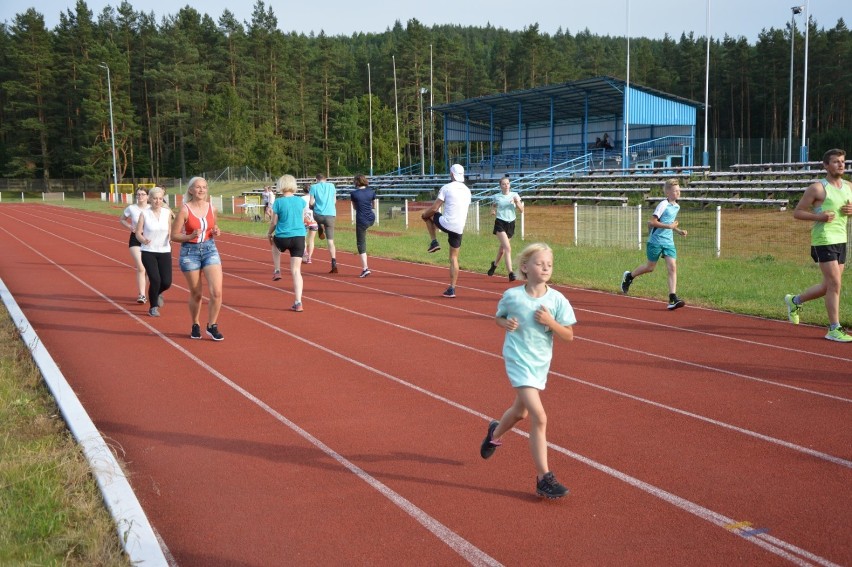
xmin=136 ymin=187 xmax=174 ymax=317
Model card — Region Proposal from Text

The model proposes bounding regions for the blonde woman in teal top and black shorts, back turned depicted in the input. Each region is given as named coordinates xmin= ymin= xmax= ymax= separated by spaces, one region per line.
xmin=266 ymin=175 xmax=307 ymax=312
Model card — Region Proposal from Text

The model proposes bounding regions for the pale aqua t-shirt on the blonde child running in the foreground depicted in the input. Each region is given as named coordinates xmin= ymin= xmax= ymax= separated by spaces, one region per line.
xmin=497 ymin=286 xmax=577 ymax=390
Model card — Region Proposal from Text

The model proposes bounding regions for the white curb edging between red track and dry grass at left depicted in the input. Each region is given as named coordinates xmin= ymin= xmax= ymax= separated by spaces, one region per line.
xmin=0 ymin=279 xmax=169 ymax=567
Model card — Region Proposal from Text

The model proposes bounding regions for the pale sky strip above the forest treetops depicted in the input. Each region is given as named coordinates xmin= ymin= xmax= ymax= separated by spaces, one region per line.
xmin=0 ymin=0 xmax=852 ymax=43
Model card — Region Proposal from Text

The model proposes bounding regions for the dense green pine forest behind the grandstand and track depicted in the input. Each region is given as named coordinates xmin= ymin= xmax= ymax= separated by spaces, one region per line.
xmin=0 ymin=0 xmax=852 ymax=180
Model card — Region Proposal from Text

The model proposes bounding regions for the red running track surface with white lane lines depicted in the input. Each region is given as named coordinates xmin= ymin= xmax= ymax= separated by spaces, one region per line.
xmin=0 ymin=204 xmax=852 ymax=566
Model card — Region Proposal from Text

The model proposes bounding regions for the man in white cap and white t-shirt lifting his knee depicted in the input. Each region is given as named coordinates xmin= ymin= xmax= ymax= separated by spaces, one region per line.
xmin=420 ymin=163 xmax=470 ymax=297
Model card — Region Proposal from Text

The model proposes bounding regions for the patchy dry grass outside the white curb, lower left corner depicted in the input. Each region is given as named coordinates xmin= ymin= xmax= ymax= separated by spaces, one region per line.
xmin=0 ymin=305 xmax=129 ymax=566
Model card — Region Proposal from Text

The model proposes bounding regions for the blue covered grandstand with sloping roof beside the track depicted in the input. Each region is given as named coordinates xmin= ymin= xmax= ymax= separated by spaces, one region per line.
xmin=433 ymin=77 xmax=703 ymax=177
